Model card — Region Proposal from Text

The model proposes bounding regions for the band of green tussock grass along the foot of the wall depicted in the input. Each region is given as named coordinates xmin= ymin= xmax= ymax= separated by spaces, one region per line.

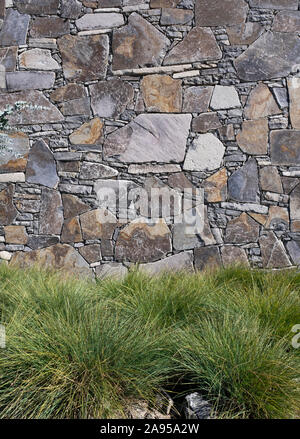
xmin=0 ymin=264 xmax=300 ymax=418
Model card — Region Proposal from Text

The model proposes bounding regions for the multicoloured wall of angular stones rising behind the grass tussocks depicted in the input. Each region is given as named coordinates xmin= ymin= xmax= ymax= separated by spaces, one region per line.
xmin=0 ymin=0 xmax=300 ymax=278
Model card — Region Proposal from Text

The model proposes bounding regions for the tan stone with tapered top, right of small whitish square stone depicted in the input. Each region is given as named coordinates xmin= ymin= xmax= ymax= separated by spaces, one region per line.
xmin=244 ymin=84 xmax=281 ymax=120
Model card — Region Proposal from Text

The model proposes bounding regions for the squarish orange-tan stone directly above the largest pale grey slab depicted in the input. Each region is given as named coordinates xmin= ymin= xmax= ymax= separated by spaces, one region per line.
xmin=141 ymin=75 xmax=182 ymax=113
